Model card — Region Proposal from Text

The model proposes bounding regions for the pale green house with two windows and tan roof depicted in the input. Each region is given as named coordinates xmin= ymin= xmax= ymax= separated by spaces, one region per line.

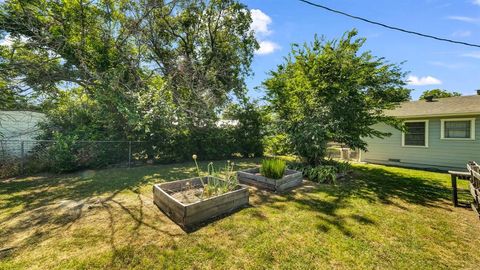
xmin=360 ymin=95 xmax=480 ymax=170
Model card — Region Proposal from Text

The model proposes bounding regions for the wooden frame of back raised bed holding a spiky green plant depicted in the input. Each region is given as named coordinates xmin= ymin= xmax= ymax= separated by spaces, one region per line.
xmin=237 ymin=168 xmax=303 ymax=192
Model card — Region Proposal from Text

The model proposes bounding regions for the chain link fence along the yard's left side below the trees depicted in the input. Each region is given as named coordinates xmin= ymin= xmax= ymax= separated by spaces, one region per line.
xmin=0 ymin=140 xmax=155 ymax=178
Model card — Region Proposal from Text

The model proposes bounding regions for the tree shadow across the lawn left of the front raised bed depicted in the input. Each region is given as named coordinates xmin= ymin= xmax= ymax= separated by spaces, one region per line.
xmin=0 ymin=160 xmax=257 ymax=255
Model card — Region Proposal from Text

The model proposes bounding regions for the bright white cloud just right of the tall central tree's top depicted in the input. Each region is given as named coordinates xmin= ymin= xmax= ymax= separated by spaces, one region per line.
xmin=250 ymin=9 xmax=280 ymax=55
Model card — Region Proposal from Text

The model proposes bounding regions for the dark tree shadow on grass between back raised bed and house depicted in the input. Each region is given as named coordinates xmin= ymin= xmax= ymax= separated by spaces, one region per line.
xmin=254 ymin=167 xmax=451 ymax=236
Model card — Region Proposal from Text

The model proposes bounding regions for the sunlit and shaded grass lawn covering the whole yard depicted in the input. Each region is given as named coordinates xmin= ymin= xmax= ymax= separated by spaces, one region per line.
xmin=0 ymin=160 xmax=480 ymax=269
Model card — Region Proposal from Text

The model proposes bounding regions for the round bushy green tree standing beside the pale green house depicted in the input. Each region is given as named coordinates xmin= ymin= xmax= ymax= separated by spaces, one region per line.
xmin=263 ymin=30 xmax=410 ymax=165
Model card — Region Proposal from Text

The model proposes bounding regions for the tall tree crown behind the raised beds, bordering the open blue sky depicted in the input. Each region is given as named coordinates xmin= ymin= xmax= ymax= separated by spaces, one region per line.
xmin=142 ymin=0 xmax=258 ymax=125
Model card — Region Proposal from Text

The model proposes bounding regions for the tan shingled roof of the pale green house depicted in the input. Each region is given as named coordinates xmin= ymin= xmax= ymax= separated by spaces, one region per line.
xmin=386 ymin=95 xmax=480 ymax=118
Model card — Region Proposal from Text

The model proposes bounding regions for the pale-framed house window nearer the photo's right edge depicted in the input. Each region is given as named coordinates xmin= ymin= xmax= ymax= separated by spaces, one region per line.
xmin=441 ymin=118 xmax=475 ymax=140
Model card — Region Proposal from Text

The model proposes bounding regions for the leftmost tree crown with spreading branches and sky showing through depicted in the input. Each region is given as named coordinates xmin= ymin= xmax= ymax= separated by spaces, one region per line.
xmin=0 ymin=0 xmax=156 ymax=139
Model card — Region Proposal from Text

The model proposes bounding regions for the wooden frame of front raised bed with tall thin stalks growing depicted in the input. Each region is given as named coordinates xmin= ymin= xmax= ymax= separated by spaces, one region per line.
xmin=153 ymin=177 xmax=249 ymax=229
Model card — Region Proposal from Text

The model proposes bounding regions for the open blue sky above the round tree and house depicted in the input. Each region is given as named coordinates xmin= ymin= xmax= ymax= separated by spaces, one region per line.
xmin=242 ymin=0 xmax=480 ymax=99
